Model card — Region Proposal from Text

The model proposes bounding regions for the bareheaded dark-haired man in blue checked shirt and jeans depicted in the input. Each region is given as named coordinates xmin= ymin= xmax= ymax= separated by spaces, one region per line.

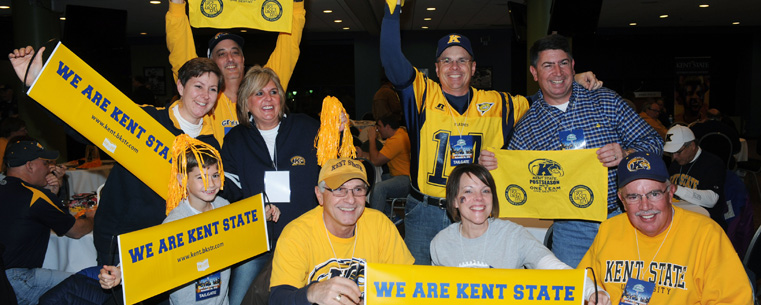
xmin=508 ymin=35 xmax=663 ymax=267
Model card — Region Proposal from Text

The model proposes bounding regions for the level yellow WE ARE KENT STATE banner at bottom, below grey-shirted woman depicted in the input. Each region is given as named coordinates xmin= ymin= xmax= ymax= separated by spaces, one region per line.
xmin=365 ymin=264 xmax=586 ymax=305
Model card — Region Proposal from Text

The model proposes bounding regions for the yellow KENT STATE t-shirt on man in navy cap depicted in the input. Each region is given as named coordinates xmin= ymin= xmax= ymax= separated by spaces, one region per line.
xmin=577 ymin=207 xmax=752 ymax=305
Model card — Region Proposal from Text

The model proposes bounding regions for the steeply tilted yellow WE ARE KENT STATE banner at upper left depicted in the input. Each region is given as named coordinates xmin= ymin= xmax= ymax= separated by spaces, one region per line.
xmin=27 ymin=42 xmax=174 ymax=198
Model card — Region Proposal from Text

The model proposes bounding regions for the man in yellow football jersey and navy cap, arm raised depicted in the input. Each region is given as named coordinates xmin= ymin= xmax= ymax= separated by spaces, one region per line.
xmin=380 ymin=1 xmax=602 ymax=265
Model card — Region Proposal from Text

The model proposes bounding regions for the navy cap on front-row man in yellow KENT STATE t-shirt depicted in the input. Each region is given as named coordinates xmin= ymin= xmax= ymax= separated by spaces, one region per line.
xmin=618 ymin=151 xmax=669 ymax=188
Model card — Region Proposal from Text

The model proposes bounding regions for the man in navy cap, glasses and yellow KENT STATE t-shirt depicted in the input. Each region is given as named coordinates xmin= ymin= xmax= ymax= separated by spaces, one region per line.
xmin=578 ymin=152 xmax=753 ymax=304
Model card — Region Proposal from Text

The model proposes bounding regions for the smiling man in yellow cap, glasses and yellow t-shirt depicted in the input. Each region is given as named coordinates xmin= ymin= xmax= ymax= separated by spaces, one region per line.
xmin=269 ymin=158 xmax=415 ymax=305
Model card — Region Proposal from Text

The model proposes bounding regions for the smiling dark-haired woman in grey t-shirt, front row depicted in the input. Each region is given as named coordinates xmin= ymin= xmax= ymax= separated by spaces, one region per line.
xmin=431 ymin=164 xmax=610 ymax=304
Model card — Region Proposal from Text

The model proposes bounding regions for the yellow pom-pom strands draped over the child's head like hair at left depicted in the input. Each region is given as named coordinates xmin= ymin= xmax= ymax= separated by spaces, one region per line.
xmin=166 ymin=134 xmax=225 ymax=215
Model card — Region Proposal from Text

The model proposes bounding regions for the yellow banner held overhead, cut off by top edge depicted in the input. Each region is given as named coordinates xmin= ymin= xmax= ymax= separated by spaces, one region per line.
xmin=188 ymin=0 xmax=293 ymax=33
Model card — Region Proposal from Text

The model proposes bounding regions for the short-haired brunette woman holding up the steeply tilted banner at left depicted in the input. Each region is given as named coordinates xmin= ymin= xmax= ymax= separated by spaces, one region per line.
xmin=8 ymin=46 xmax=222 ymax=302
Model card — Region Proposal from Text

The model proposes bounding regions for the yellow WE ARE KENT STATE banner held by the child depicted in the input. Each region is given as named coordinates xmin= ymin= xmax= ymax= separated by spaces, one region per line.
xmin=119 ymin=194 xmax=270 ymax=304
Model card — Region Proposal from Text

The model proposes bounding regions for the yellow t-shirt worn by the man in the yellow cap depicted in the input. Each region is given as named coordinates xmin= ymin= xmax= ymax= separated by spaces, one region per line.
xmin=270 ymin=206 xmax=415 ymax=291
